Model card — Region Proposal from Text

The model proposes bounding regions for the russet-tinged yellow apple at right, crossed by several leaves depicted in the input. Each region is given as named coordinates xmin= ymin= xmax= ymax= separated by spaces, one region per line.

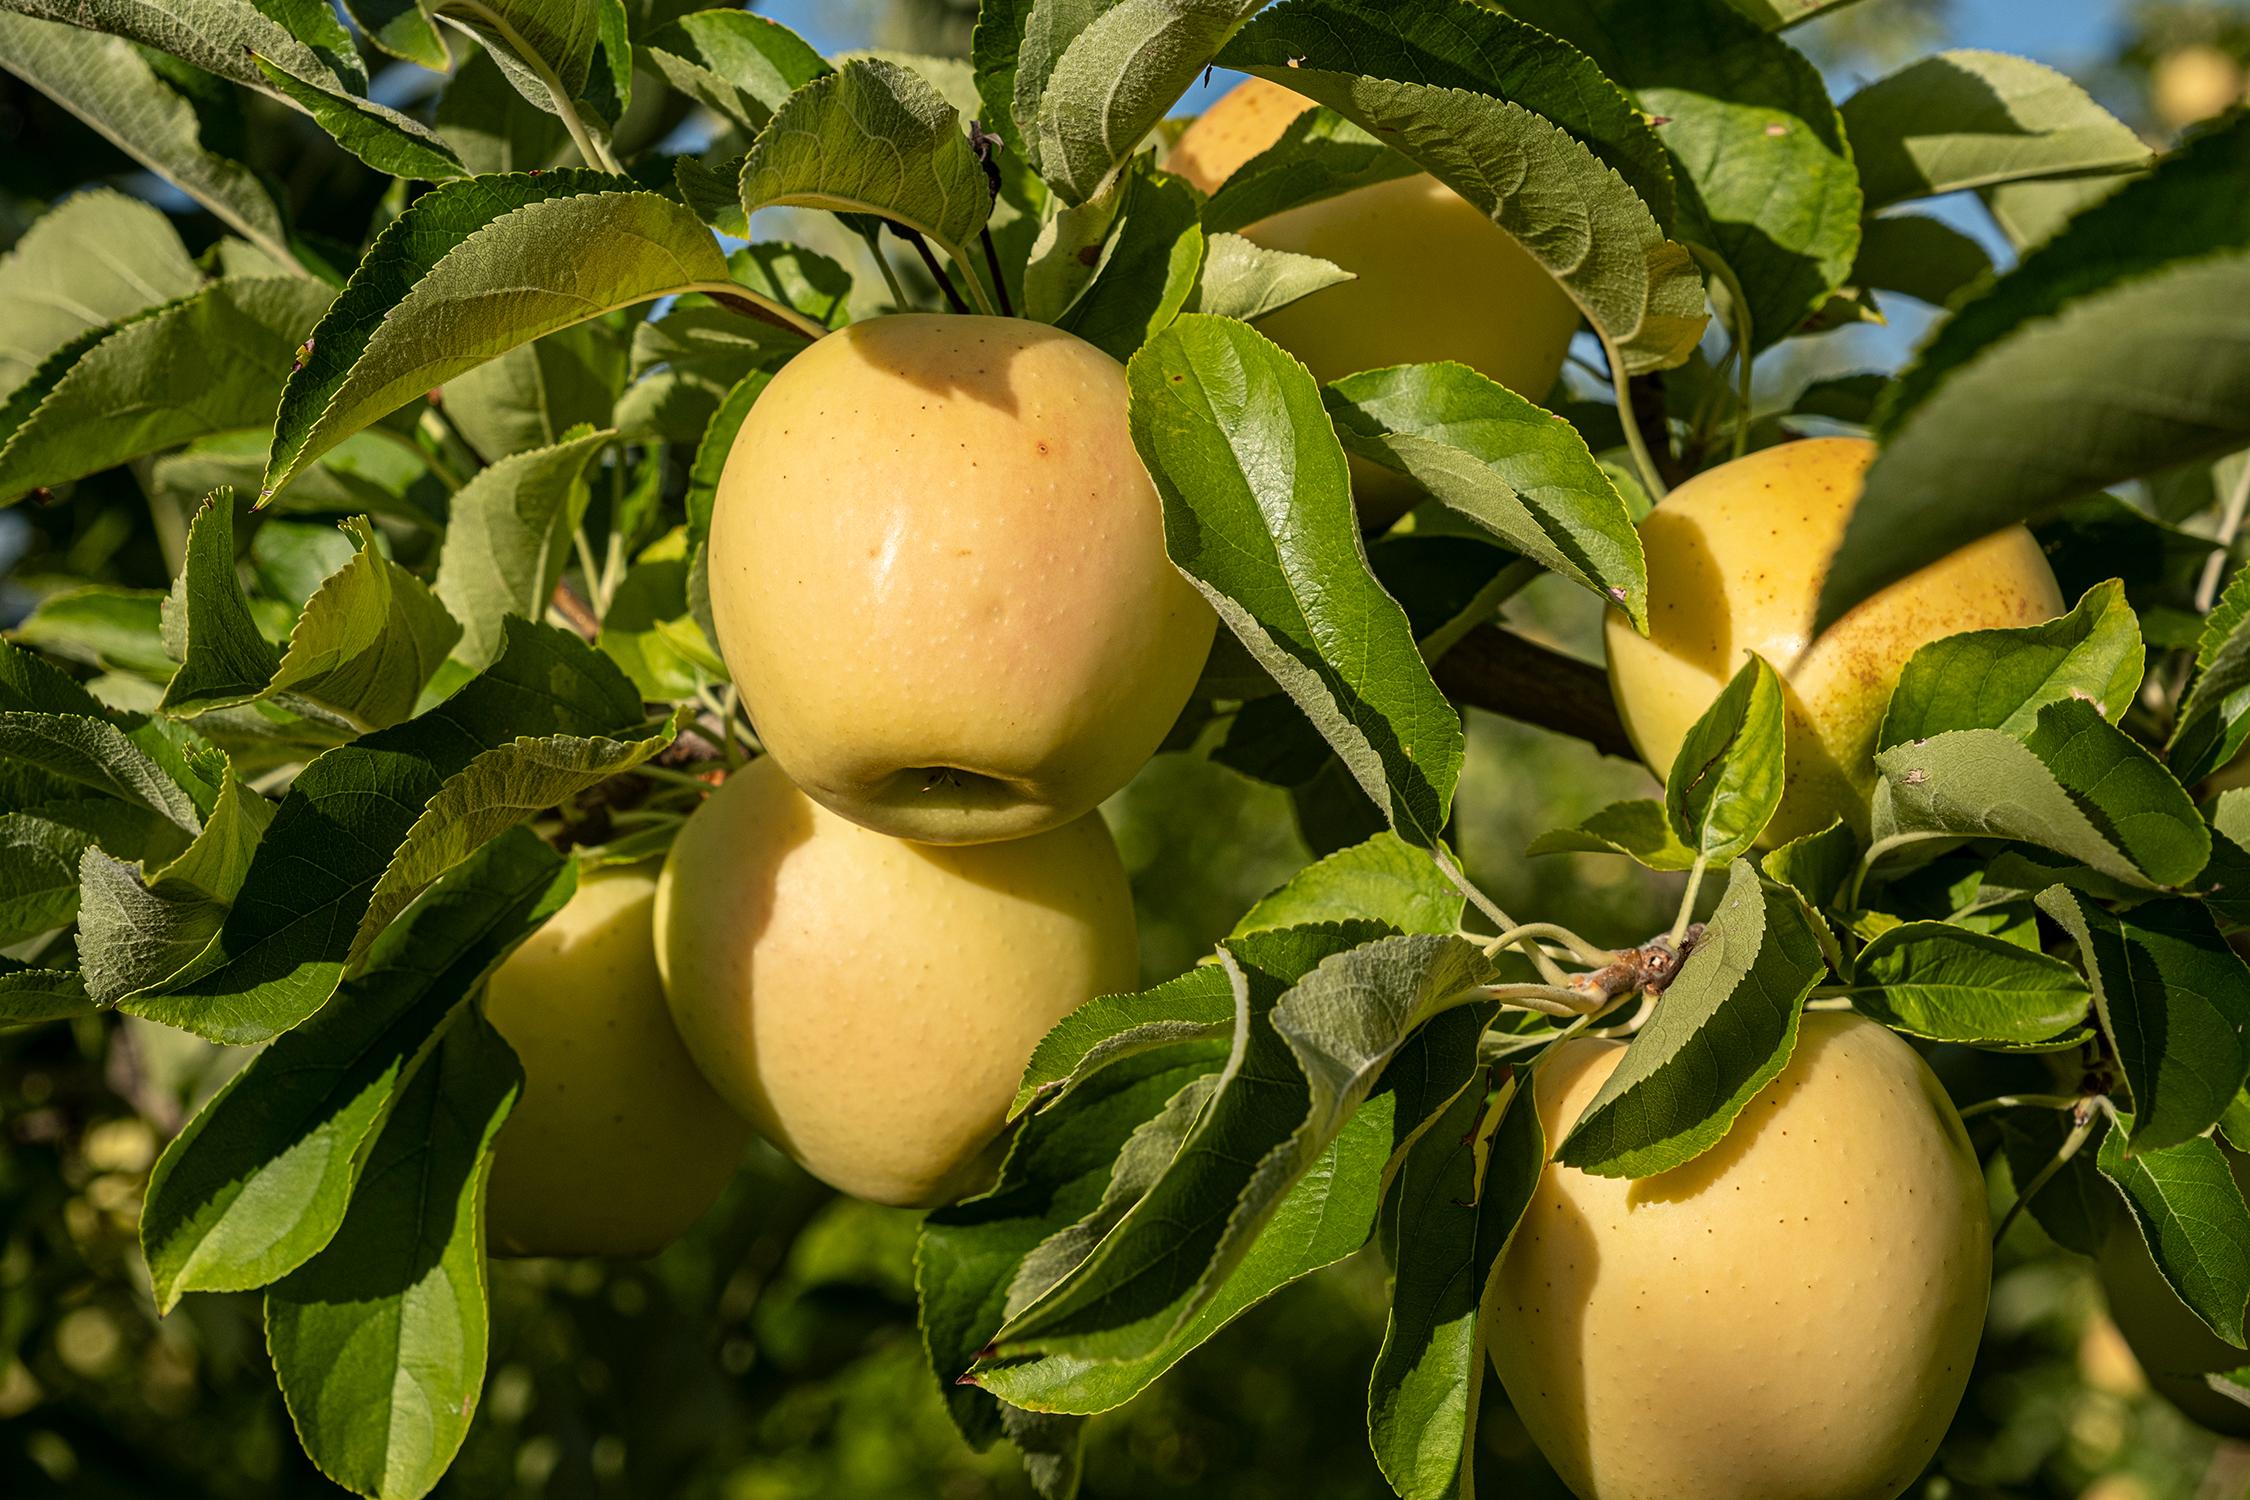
xmin=1604 ymin=439 xmax=2063 ymax=846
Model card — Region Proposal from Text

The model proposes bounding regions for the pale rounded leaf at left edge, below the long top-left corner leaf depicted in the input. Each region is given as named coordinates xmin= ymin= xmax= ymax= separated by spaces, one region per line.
xmin=0 ymin=187 xmax=203 ymax=396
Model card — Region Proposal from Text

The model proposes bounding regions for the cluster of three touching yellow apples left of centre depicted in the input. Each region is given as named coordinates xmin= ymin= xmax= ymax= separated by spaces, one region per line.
xmin=486 ymin=315 xmax=1217 ymax=1255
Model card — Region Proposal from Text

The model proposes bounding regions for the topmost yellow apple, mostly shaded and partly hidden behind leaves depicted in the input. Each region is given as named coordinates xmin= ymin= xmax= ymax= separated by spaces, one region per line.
xmin=1166 ymin=79 xmax=1577 ymax=513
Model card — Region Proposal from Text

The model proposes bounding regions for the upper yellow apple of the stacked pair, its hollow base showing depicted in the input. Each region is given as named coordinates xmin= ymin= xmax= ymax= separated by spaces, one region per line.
xmin=711 ymin=315 xmax=1217 ymax=843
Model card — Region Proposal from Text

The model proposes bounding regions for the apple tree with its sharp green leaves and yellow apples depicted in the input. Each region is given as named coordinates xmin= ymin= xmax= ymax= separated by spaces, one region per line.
xmin=0 ymin=0 xmax=2250 ymax=1500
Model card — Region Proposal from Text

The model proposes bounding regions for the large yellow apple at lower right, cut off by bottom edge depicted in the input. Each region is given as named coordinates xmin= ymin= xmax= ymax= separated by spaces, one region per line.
xmin=1487 ymin=1012 xmax=1991 ymax=1500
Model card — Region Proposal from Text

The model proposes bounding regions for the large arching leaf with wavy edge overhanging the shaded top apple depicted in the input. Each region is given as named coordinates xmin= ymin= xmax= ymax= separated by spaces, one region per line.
xmin=1220 ymin=0 xmax=1708 ymax=371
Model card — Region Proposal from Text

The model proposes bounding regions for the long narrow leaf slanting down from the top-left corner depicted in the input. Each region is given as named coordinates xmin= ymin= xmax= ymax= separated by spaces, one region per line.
xmin=0 ymin=7 xmax=295 ymax=265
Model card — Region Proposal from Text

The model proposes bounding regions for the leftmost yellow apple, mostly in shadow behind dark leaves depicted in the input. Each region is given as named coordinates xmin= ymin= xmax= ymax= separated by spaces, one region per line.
xmin=484 ymin=868 xmax=749 ymax=1255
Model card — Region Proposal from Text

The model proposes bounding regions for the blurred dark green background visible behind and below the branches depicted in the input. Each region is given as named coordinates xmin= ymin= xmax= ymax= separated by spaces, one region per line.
xmin=0 ymin=0 xmax=2250 ymax=1500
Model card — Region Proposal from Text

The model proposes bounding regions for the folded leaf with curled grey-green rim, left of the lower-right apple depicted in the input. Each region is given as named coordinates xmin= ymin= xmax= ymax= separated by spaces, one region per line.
xmin=979 ymin=929 xmax=1492 ymax=1376
